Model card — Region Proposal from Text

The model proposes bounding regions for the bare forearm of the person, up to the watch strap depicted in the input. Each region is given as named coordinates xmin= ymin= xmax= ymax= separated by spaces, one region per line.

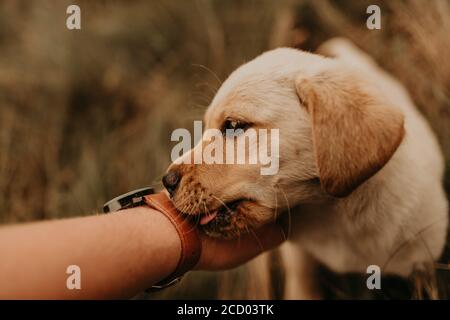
xmin=0 ymin=207 xmax=181 ymax=299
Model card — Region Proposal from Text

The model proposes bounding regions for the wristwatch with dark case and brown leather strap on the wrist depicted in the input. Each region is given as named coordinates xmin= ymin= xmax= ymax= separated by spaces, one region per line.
xmin=103 ymin=187 xmax=202 ymax=292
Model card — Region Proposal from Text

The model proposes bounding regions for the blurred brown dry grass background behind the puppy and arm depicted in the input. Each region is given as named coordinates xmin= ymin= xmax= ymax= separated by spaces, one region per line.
xmin=0 ymin=0 xmax=450 ymax=298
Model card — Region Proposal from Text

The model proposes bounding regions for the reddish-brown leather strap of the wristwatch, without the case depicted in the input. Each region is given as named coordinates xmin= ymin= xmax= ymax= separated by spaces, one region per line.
xmin=144 ymin=192 xmax=202 ymax=287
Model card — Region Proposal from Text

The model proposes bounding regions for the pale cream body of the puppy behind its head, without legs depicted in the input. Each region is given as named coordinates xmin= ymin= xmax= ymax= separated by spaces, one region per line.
xmin=286 ymin=40 xmax=448 ymax=276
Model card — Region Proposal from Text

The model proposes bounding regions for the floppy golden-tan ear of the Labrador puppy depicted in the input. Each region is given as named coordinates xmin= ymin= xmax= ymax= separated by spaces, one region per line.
xmin=295 ymin=70 xmax=404 ymax=197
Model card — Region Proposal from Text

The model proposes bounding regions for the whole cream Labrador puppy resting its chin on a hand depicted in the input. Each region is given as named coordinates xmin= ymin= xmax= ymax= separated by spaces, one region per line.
xmin=163 ymin=39 xmax=448 ymax=298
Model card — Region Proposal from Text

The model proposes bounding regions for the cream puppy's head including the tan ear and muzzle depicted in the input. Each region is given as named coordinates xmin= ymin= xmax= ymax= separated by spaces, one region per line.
xmin=163 ymin=49 xmax=403 ymax=237
